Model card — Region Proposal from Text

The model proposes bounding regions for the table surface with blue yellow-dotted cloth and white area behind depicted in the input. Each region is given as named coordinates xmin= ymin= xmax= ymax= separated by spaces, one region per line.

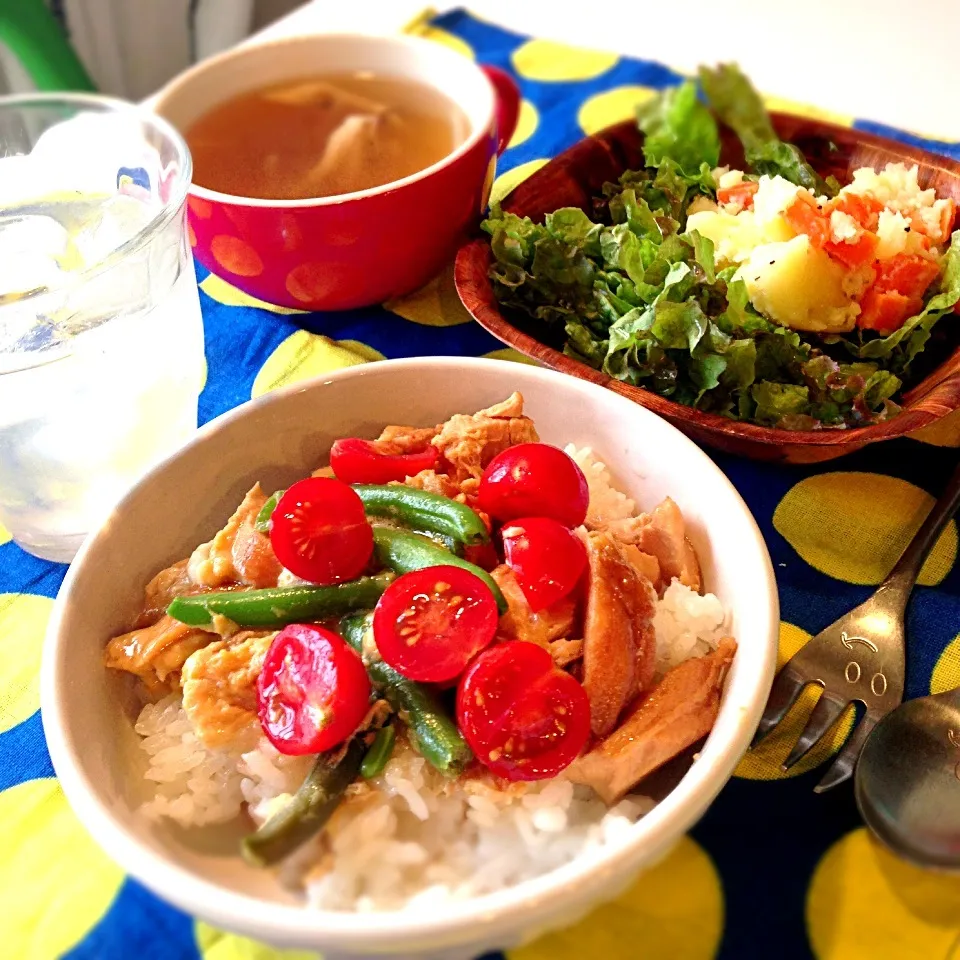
xmin=0 ymin=7 xmax=960 ymax=960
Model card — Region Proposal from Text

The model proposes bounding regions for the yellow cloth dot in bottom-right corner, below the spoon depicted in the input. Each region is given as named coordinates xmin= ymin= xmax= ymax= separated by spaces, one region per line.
xmin=806 ymin=827 xmax=960 ymax=960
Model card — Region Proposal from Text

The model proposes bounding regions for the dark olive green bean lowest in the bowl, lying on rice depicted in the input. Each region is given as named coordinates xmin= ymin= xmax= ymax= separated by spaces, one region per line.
xmin=240 ymin=736 xmax=367 ymax=867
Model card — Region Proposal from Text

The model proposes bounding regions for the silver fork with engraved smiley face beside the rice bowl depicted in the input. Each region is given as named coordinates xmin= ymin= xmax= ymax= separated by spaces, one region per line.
xmin=753 ymin=466 xmax=960 ymax=793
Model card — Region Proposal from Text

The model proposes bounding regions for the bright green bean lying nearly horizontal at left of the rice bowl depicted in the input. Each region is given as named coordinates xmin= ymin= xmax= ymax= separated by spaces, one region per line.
xmin=167 ymin=570 xmax=394 ymax=629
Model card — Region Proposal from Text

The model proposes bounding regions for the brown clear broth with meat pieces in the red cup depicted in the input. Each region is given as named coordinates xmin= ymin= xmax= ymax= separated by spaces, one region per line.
xmin=186 ymin=71 xmax=470 ymax=200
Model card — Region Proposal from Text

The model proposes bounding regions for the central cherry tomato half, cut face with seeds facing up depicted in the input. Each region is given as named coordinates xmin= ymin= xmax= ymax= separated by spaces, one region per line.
xmin=373 ymin=566 xmax=498 ymax=683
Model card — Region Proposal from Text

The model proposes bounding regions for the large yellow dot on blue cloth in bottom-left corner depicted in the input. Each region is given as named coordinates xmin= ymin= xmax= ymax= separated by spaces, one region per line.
xmin=0 ymin=777 xmax=123 ymax=960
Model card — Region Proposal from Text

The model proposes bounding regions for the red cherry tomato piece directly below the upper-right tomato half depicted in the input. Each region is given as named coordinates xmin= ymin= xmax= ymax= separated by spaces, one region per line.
xmin=500 ymin=517 xmax=587 ymax=613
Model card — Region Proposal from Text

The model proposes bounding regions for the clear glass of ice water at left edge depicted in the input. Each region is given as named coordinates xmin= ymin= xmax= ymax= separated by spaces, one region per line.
xmin=0 ymin=94 xmax=206 ymax=561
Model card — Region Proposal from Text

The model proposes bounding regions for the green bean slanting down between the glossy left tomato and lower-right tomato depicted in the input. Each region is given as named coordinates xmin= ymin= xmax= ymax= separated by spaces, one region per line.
xmin=340 ymin=613 xmax=473 ymax=777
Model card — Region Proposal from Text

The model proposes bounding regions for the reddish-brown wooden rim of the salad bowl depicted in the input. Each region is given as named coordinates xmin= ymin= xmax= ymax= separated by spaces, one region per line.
xmin=454 ymin=111 xmax=960 ymax=446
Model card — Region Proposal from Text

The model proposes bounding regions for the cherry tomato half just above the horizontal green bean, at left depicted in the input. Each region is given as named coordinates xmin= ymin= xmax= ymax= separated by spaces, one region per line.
xmin=270 ymin=477 xmax=373 ymax=583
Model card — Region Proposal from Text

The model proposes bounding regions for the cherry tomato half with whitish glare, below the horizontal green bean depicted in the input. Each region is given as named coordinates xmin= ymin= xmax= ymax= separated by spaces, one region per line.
xmin=257 ymin=623 xmax=370 ymax=756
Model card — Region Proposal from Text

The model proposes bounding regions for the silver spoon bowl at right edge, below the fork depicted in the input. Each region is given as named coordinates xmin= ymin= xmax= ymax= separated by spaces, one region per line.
xmin=854 ymin=467 xmax=960 ymax=869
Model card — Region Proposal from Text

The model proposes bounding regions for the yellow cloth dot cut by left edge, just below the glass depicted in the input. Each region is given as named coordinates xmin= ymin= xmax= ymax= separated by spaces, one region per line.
xmin=0 ymin=593 xmax=53 ymax=733
